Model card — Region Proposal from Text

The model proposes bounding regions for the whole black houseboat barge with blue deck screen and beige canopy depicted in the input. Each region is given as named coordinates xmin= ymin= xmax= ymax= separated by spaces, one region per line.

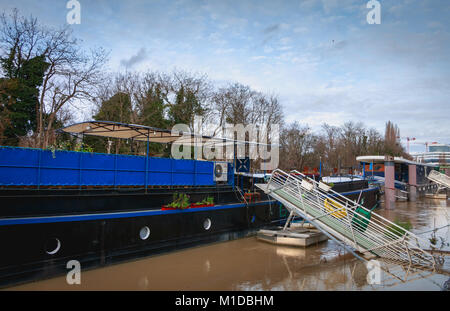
xmin=0 ymin=121 xmax=378 ymax=287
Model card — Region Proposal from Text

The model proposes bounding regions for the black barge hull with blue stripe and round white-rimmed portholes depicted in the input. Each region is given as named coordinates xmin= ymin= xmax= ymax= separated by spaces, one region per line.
xmin=0 ymin=188 xmax=378 ymax=287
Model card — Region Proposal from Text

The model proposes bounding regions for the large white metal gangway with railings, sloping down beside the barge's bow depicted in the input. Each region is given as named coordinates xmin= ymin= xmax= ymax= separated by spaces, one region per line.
xmin=256 ymin=169 xmax=436 ymax=270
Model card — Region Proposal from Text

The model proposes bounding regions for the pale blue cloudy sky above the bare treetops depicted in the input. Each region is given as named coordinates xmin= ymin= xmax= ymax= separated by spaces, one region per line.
xmin=0 ymin=0 xmax=450 ymax=152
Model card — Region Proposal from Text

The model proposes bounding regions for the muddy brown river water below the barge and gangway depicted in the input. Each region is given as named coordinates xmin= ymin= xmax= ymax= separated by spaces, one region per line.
xmin=9 ymin=199 xmax=450 ymax=291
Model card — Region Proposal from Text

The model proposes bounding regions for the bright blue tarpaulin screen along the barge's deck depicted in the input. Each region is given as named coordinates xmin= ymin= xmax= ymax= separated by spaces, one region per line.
xmin=0 ymin=146 xmax=219 ymax=186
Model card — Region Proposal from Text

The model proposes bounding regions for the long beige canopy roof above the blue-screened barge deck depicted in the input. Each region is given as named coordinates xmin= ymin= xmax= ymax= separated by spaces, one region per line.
xmin=59 ymin=121 xmax=276 ymax=145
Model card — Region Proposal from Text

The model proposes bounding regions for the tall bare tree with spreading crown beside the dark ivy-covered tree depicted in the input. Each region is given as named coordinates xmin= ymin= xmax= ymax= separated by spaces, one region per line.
xmin=0 ymin=10 xmax=107 ymax=148
